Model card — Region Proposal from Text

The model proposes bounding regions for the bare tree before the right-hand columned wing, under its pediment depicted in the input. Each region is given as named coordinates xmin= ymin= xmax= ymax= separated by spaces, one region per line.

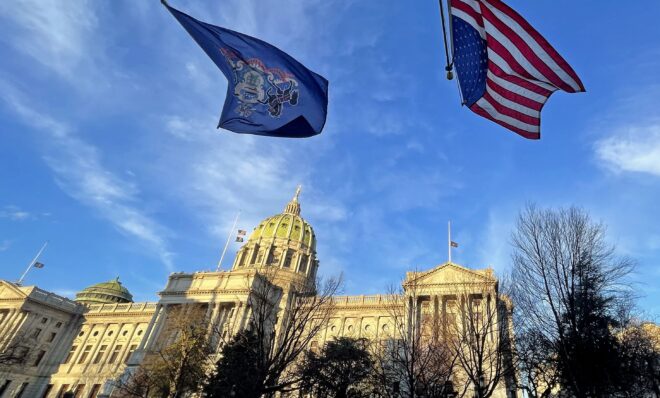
xmin=445 ymin=284 xmax=514 ymax=398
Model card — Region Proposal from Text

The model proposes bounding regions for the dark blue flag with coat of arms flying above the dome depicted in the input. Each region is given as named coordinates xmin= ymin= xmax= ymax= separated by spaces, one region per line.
xmin=163 ymin=1 xmax=328 ymax=137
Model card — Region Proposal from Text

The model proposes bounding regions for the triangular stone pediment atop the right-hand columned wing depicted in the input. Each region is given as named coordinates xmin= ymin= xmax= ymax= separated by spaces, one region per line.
xmin=406 ymin=262 xmax=497 ymax=285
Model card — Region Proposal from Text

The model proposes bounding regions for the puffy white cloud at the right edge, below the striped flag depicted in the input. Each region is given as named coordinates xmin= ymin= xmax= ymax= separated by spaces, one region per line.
xmin=595 ymin=123 xmax=660 ymax=177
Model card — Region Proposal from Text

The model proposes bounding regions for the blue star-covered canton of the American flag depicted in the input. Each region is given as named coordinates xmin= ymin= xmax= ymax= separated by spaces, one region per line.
xmin=452 ymin=16 xmax=488 ymax=106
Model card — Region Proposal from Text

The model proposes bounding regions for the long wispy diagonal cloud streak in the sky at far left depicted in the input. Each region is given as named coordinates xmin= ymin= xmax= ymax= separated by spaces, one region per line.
xmin=0 ymin=82 xmax=173 ymax=271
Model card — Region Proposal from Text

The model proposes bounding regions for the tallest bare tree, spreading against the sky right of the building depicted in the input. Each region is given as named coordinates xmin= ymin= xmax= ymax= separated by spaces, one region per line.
xmin=512 ymin=205 xmax=632 ymax=397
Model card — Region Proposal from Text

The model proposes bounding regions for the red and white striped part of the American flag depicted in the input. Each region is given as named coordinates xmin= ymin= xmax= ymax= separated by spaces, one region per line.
xmin=451 ymin=0 xmax=584 ymax=139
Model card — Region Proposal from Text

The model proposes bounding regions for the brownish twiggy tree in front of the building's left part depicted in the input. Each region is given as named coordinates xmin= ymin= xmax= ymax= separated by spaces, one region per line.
xmin=116 ymin=304 xmax=213 ymax=398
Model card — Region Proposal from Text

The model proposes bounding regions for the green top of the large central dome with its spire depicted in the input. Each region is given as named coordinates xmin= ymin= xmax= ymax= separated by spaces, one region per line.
xmin=249 ymin=187 xmax=316 ymax=249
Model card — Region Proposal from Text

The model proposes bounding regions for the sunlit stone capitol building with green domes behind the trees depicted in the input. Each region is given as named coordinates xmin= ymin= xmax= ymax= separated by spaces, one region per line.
xmin=0 ymin=192 xmax=517 ymax=398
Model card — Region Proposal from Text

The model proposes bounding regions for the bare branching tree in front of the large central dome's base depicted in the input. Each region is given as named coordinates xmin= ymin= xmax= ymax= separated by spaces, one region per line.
xmin=206 ymin=268 xmax=341 ymax=396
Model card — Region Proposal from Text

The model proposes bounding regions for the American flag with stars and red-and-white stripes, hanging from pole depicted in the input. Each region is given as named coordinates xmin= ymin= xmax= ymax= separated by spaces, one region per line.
xmin=450 ymin=0 xmax=584 ymax=139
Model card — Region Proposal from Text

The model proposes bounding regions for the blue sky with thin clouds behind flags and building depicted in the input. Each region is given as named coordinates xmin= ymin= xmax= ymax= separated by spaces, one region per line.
xmin=0 ymin=0 xmax=660 ymax=314
